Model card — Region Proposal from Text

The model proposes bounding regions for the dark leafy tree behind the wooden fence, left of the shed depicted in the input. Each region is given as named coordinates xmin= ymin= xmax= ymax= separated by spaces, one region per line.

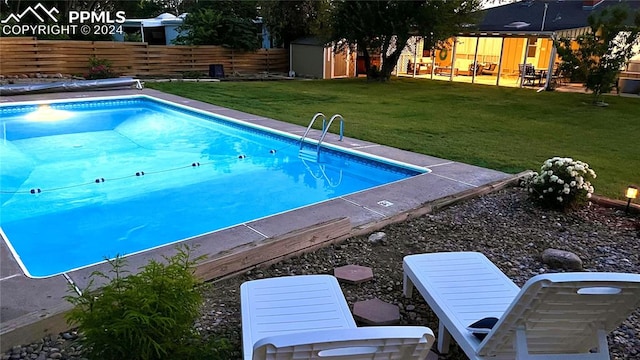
xmin=175 ymin=1 xmax=260 ymax=50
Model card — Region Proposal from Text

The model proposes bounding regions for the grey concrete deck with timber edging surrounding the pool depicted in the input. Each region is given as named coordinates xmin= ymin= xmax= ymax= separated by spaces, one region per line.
xmin=0 ymin=89 xmax=517 ymax=352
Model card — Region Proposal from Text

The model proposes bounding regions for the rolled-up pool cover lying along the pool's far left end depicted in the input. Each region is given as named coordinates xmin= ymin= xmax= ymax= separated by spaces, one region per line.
xmin=0 ymin=77 xmax=142 ymax=95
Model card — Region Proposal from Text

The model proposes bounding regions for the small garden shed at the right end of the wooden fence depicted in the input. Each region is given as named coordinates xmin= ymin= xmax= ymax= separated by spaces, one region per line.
xmin=289 ymin=37 xmax=356 ymax=79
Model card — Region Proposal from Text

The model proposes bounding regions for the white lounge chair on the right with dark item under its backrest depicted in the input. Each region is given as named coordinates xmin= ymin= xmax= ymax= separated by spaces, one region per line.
xmin=403 ymin=252 xmax=640 ymax=360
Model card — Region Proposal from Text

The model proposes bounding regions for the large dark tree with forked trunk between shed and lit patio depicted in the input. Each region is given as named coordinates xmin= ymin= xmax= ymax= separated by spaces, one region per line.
xmin=327 ymin=0 xmax=480 ymax=81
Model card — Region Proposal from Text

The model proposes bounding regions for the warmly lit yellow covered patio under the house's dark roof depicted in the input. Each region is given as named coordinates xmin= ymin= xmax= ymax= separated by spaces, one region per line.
xmin=396 ymin=32 xmax=563 ymax=88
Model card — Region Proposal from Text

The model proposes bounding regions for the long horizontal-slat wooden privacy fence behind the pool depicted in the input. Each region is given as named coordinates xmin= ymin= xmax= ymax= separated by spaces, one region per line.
xmin=0 ymin=37 xmax=289 ymax=76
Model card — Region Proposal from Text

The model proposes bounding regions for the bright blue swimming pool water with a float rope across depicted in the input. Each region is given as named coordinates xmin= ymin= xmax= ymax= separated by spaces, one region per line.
xmin=0 ymin=97 xmax=425 ymax=277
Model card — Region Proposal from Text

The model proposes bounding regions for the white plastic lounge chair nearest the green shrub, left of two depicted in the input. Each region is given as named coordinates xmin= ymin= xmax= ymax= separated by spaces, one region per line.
xmin=240 ymin=275 xmax=435 ymax=360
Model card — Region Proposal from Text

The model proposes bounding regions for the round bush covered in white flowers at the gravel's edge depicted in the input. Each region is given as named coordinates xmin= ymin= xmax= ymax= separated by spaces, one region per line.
xmin=528 ymin=157 xmax=596 ymax=210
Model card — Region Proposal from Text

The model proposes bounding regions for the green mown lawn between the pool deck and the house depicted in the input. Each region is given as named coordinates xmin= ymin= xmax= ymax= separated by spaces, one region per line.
xmin=146 ymin=79 xmax=640 ymax=198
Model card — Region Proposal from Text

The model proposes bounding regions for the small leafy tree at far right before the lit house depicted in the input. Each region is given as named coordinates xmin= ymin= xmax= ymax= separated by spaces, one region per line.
xmin=556 ymin=6 xmax=640 ymax=104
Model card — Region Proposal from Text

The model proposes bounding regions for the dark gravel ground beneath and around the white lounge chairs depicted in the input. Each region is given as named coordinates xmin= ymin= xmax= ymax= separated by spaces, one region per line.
xmin=2 ymin=188 xmax=640 ymax=360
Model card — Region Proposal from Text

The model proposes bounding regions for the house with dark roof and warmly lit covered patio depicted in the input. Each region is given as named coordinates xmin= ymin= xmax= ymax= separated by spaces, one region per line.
xmin=396 ymin=0 xmax=640 ymax=88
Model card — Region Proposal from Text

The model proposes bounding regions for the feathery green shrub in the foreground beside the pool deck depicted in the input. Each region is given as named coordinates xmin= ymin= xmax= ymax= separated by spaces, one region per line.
xmin=66 ymin=246 xmax=227 ymax=360
